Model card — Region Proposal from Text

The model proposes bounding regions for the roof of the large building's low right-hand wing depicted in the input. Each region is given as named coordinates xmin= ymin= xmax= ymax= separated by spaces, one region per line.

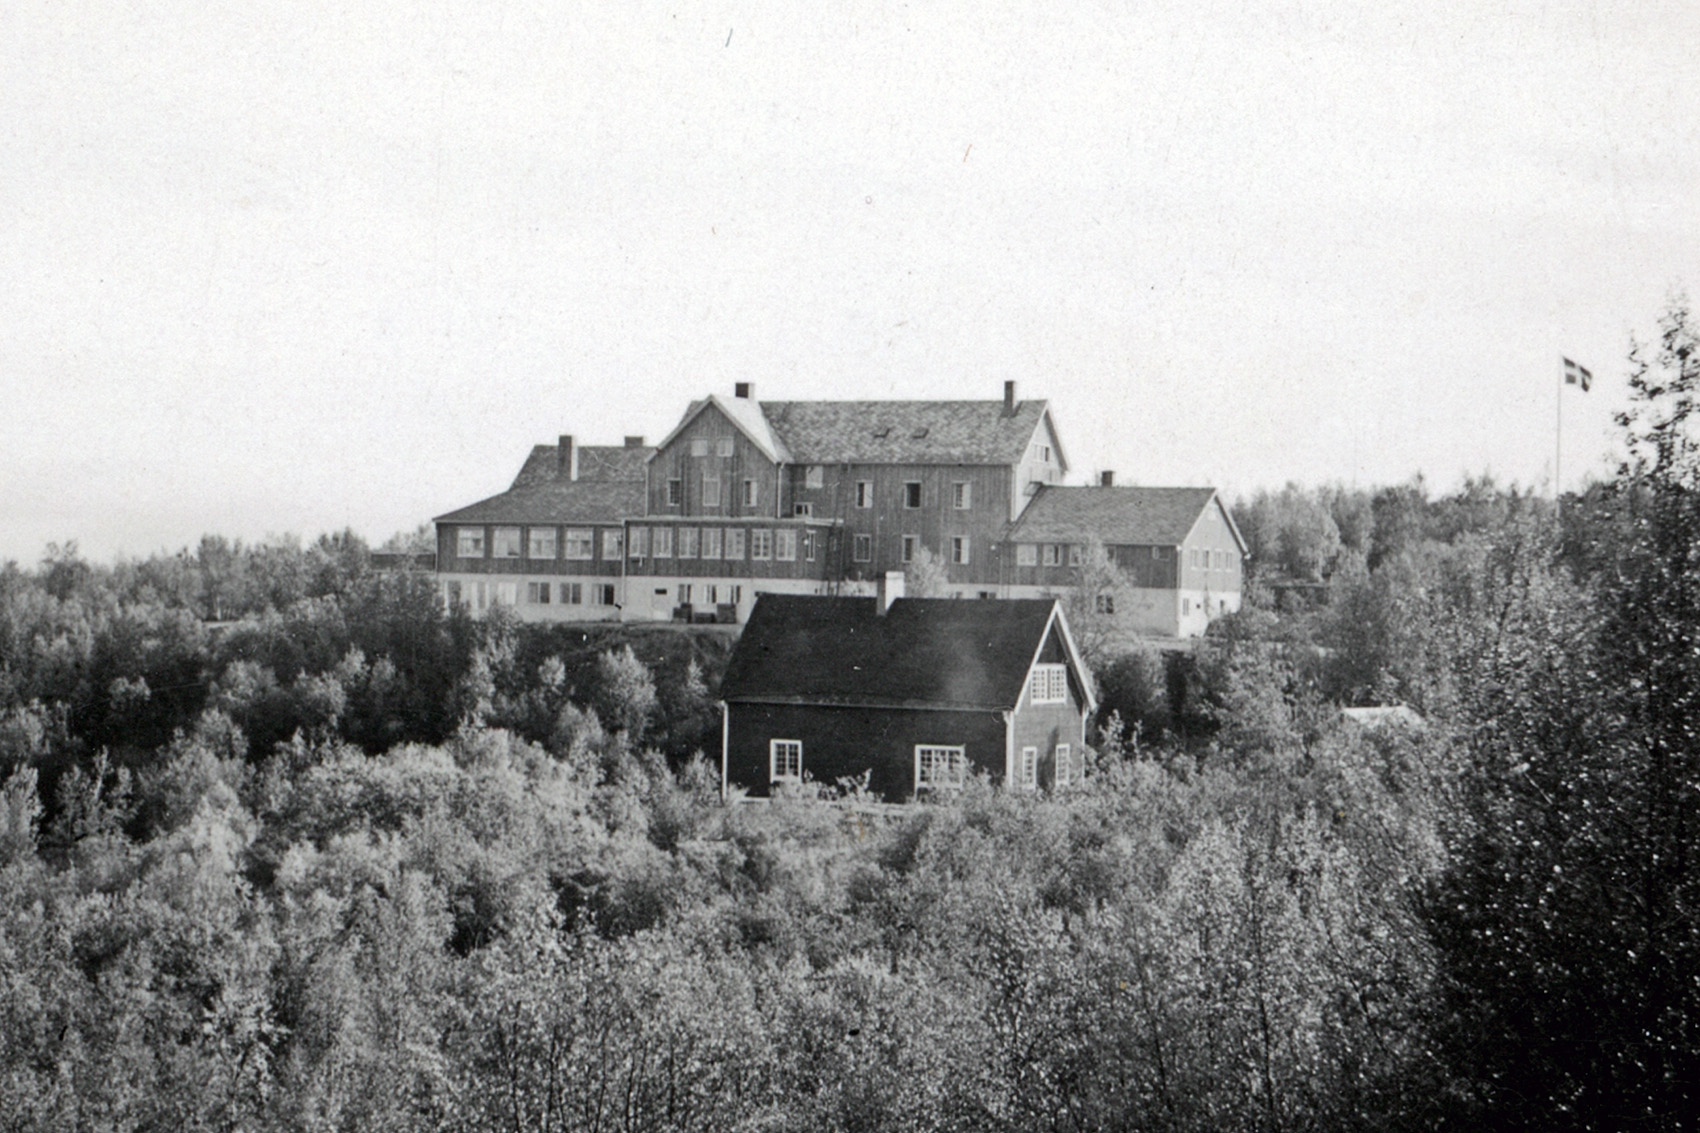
xmin=1008 ymin=485 xmax=1216 ymax=546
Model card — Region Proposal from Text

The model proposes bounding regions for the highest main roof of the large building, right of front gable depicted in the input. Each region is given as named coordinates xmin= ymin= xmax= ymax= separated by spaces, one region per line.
xmin=762 ymin=401 xmax=1061 ymax=464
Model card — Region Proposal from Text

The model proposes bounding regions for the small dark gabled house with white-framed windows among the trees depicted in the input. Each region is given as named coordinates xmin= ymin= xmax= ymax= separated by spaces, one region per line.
xmin=721 ymin=575 xmax=1095 ymax=801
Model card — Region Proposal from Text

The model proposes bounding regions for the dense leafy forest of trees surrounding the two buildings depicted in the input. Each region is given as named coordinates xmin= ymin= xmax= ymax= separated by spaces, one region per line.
xmin=0 ymin=306 xmax=1700 ymax=1131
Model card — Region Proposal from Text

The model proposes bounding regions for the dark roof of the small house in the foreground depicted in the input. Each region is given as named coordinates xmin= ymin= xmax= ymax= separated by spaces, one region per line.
xmin=721 ymin=594 xmax=1056 ymax=709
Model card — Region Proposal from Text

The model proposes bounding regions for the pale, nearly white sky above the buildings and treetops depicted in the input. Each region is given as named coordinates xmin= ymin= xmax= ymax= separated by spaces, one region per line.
xmin=0 ymin=0 xmax=1700 ymax=563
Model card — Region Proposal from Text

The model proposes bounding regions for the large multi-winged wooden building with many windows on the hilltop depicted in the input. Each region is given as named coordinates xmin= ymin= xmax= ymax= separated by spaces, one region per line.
xmin=435 ymin=381 xmax=1244 ymax=636
